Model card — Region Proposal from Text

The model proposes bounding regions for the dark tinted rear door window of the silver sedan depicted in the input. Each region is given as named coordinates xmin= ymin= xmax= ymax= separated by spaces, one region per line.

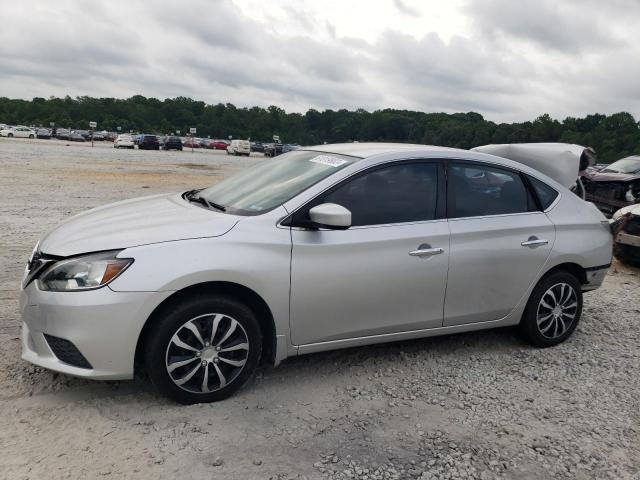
xmin=448 ymin=162 xmax=535 ymax=218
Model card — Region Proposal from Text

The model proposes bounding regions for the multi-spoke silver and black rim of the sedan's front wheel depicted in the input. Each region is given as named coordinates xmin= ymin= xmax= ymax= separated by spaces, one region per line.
xmin=165 ymin=313 xmax=249 ymax=393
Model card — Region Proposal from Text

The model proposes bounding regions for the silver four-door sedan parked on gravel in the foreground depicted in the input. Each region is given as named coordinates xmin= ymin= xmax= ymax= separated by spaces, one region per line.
xmin=21 ymin=143 xmax=612 ymax=403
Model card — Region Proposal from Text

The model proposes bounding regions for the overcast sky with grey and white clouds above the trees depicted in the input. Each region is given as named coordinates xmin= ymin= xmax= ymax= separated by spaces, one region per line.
xmin=0 ymin=0 xmax=640 ymax=121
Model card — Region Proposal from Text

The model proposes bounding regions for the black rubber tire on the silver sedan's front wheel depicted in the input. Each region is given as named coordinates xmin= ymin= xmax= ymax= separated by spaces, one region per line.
xmin=144 ymin=295 xmax=262 ymax=404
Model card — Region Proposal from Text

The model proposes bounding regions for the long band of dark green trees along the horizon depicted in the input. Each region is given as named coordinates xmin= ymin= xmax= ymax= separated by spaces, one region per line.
xmin=0 ymin=95 xmax=640 ymax=162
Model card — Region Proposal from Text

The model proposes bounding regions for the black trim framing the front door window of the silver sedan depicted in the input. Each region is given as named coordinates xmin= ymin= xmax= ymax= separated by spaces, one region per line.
xmin=279 ymin=157 xmax=447 ymax=230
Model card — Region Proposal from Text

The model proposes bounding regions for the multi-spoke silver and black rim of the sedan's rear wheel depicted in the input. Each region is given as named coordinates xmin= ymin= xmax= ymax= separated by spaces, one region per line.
xmin=536 ymin=283 xmax=578 ymax=339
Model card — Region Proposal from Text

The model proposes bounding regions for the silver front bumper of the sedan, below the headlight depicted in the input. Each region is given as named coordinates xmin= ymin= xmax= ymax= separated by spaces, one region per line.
xmin=20 ymin=282 xmax=172 ymax=380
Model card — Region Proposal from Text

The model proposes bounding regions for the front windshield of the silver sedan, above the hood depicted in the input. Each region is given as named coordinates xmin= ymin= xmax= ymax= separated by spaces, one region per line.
xmin=199 ymin=150 xmax=359 ymax=215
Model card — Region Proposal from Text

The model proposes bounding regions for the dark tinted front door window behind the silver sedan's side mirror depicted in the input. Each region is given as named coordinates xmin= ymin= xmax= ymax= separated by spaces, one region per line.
xmin=314 ymin=163 xmax=438 ymax=226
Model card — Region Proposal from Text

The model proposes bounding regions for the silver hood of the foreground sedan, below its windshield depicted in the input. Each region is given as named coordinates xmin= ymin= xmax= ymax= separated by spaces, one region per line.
xmin=39 ymin=194 xmax=240 ymax=257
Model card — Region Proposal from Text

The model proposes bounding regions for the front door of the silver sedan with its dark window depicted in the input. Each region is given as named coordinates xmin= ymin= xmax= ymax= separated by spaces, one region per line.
xmin=290 ymin=161 xmax=449 ymax=345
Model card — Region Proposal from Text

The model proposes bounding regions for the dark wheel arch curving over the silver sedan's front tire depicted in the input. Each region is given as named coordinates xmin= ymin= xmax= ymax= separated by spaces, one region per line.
xmin=134 ymin=281 xmax=277 ymax=372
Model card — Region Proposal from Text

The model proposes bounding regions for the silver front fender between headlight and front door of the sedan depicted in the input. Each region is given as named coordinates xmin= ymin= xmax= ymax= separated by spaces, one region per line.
xmin=109 ymin=221 xmax=291 ymax=350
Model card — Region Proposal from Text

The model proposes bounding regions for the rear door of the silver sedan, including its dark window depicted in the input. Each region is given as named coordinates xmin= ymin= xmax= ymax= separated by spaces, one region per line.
xmin=444 ymin=161 xmax=555 ymax=325
